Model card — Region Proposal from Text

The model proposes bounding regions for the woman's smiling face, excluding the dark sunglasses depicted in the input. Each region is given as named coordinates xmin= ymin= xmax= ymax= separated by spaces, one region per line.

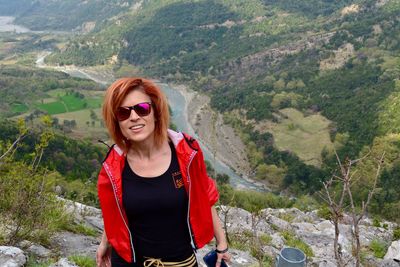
xmin=119 ymin=89 xmax=155 ymax=147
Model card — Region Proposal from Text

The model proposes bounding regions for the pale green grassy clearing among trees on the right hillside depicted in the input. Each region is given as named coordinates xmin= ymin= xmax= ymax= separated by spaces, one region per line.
xmin=257 ymin=108 xmax=332 ymax=166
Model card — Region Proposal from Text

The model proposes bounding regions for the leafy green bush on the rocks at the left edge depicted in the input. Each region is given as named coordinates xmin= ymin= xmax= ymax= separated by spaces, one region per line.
xmin=0 ymin=162 xmax=69 ymax=245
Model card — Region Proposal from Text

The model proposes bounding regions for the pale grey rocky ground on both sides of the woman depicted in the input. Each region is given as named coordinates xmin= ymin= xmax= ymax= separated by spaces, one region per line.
xmin=0 ymin=201 xmax=400 ymax=267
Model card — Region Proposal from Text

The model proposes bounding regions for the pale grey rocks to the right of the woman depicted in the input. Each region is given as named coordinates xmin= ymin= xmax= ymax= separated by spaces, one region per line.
xmin=219 ymin=206 xmax=400 ymax=266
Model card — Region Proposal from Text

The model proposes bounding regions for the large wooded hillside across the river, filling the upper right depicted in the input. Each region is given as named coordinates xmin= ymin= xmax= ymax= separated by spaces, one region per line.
xmin=2 ymin=0 xmax=400 ymax=222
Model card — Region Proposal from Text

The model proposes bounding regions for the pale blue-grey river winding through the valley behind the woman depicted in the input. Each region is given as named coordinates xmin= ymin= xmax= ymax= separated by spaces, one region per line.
xmin=36 ymin=52 xmax=265 ymax=191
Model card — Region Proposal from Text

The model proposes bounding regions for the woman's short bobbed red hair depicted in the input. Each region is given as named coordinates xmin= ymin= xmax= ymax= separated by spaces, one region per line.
xmin=103 ymin=77 xmax=169 ymax=152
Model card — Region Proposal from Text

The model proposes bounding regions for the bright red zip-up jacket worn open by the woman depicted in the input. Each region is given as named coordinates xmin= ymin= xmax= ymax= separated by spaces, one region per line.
xmin=97 ymin=130 xmax=219 ymax=262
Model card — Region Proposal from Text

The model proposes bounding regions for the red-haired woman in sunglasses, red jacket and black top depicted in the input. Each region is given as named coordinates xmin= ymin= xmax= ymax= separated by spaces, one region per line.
xmin=96 ymin=78 xmax=230 ymax=267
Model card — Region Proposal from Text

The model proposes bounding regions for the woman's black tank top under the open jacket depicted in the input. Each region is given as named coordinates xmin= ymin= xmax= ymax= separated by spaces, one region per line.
xmin=111 ymin=143 xmax=193 ymax=264
